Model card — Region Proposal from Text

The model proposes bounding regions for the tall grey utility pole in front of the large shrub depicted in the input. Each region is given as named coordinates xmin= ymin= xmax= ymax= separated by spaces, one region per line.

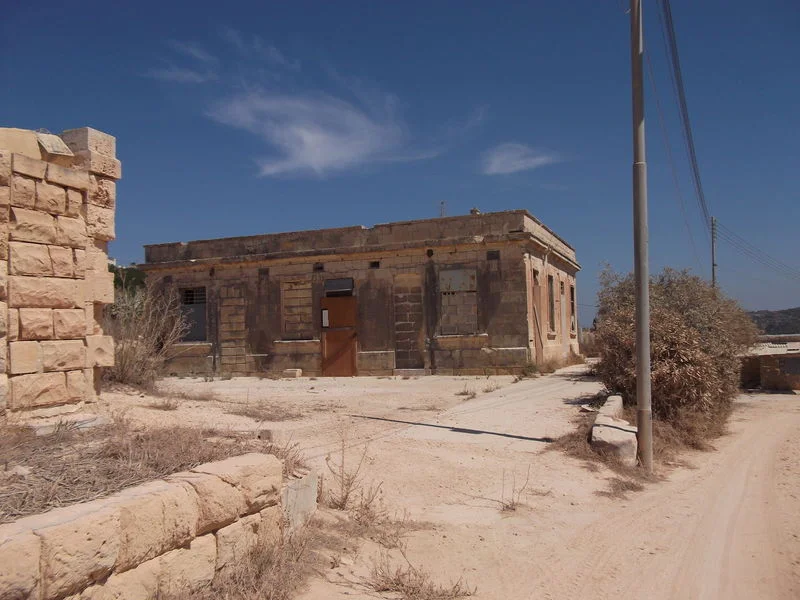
xmin=631 ymin=0 xmax=653 ymax=473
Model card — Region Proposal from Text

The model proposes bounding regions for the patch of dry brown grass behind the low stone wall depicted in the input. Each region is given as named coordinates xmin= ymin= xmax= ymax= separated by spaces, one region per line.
xmin=0 ymin=418 xmax=302 ymax=523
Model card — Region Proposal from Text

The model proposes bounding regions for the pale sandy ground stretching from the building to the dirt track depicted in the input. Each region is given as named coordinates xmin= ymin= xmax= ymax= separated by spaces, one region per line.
xmin=97 ymin=367 xmax=800 ymax=600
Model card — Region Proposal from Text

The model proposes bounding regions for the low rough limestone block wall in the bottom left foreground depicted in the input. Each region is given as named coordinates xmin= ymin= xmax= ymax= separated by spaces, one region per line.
xmin=0 ymin=454 xmax=283 ymax=600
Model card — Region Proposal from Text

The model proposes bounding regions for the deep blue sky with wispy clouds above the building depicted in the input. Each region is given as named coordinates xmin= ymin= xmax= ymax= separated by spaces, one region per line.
xmin=0 ymin=0 xmax=800 ymax=323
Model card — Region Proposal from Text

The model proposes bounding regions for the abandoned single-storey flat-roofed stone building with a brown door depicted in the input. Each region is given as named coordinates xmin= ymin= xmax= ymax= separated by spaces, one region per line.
xmin=141 ymin=210 xmax=580 ymax=376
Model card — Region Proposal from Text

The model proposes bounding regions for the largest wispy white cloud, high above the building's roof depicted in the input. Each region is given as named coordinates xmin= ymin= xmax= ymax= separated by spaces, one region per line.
xmin=209 ymin=91 xmax=412 ymax=175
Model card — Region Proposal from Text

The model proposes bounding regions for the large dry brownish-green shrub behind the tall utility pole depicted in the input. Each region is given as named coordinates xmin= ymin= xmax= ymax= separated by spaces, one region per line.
xmin=596 ymin=269 xmax=757 ymax=446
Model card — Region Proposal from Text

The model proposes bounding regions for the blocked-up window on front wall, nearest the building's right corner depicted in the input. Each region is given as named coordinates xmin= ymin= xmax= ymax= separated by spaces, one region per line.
xmin=439 ymin=269 xmax=478 ymax=335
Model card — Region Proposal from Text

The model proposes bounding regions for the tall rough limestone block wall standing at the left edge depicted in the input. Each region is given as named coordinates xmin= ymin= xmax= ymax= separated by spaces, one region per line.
xmin=0 ymin=127 xmax=121 ymax=414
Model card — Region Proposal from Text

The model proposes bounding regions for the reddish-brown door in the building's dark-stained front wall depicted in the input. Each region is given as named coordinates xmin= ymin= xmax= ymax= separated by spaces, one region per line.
xmin=320 ymin=296 xmax=358 ymax=377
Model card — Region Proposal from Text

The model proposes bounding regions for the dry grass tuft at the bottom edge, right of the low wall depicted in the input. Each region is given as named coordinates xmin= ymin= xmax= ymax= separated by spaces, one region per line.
xmin=367 ymin=549 xmax=477 ymax=600
